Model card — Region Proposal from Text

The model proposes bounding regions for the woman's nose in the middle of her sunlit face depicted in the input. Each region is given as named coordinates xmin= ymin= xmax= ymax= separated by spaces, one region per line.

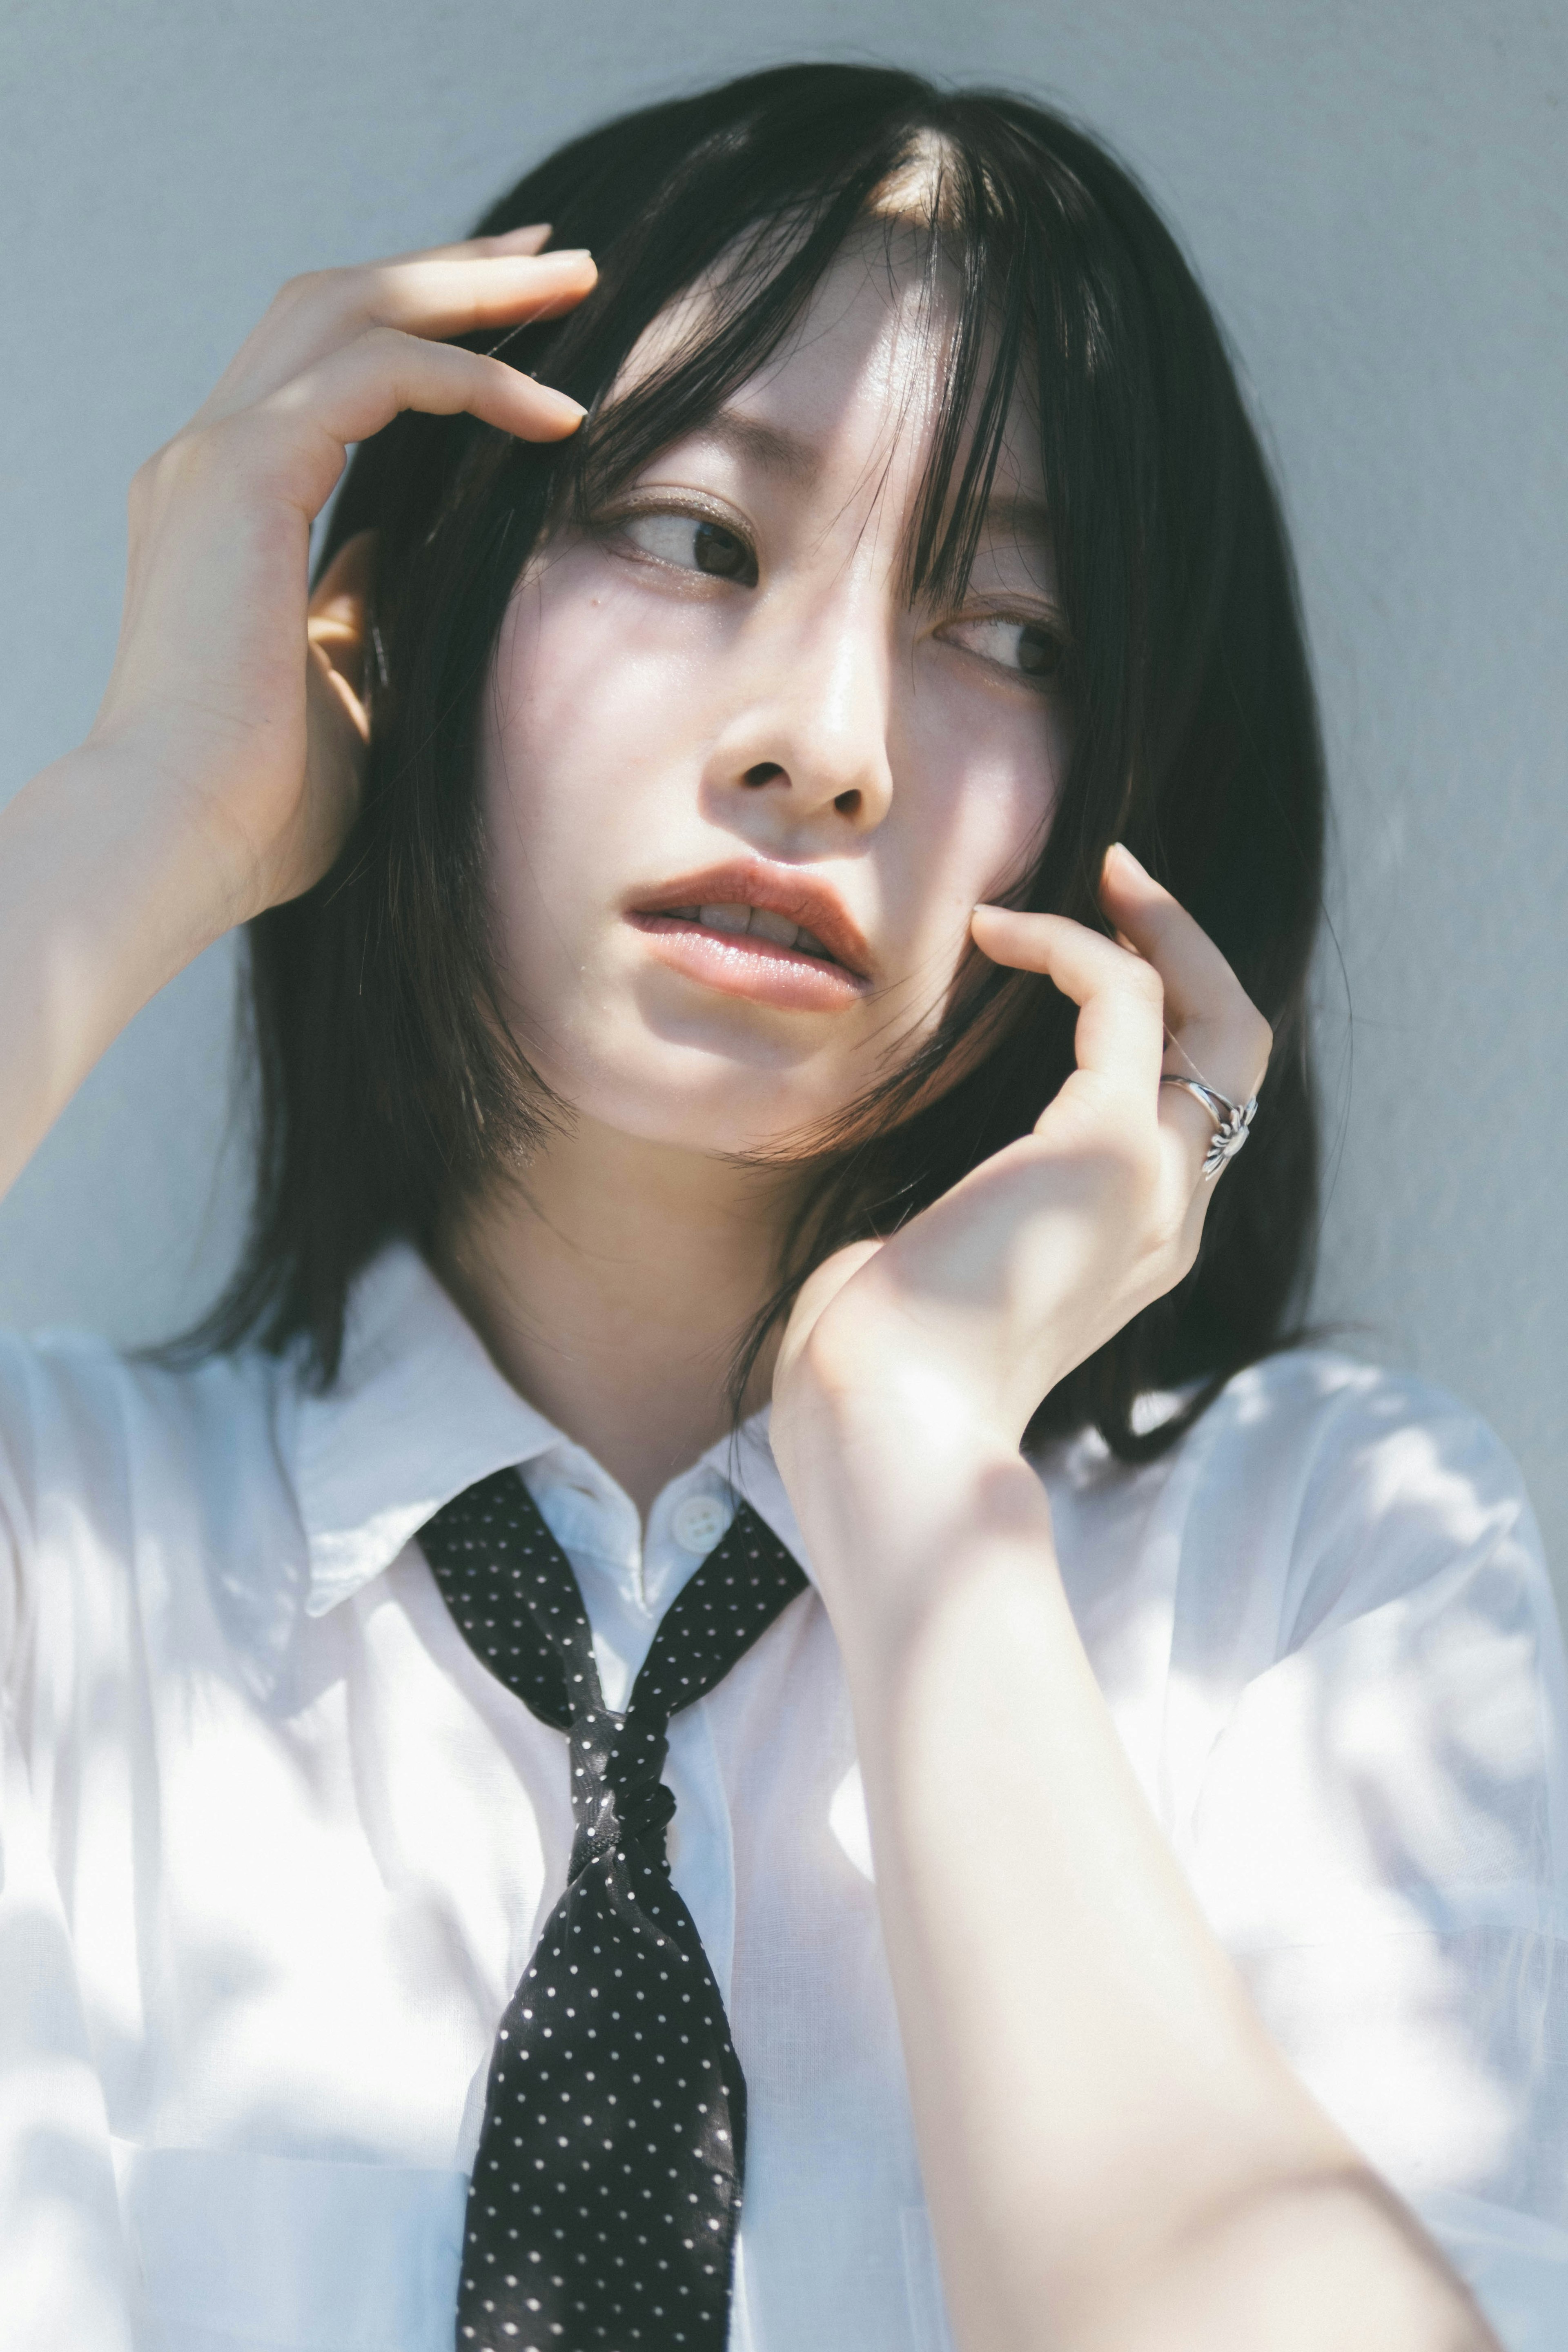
xmin=710 ymin=590 xmax=893 ymax=833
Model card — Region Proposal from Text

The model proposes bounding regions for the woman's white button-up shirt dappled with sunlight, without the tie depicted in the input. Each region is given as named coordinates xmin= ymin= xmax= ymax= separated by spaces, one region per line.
xmin=0 ymin=1249 xmax=1568 ymax=2352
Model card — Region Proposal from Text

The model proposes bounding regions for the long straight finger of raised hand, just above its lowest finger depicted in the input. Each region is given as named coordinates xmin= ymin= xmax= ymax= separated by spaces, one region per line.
xmin=198 ymin=240 xmax=597 ymax=423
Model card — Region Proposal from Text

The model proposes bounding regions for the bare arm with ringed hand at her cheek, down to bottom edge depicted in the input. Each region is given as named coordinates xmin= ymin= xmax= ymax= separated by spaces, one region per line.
xmin=773 ymin=861 xmax=1493 ymax=2352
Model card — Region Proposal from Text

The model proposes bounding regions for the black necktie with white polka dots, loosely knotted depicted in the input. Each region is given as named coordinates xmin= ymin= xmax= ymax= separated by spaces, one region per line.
xmin=419 ymin=1470 xmax=806 ymax=2352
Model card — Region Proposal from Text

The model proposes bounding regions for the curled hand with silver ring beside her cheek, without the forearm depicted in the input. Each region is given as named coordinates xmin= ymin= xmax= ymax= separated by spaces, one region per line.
xmin=773 ymin=847 xmax=1272 ymax=1482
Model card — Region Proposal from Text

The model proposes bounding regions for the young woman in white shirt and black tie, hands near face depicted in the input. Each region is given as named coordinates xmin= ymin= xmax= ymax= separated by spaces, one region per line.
xmin=0 ymin=50 xmax=1568 ymax=2352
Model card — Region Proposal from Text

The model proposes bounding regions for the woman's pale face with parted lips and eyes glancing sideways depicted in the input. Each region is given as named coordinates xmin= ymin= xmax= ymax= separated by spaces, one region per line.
xmin=482 ymin=233 xmax=1065 ymax=1152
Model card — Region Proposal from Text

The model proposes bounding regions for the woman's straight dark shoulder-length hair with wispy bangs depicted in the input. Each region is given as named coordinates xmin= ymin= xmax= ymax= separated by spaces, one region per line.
xmin=195 ymin=66 xmax=1323 ymax=1461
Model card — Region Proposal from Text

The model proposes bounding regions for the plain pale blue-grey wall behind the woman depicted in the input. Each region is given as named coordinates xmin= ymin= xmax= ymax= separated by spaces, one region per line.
xmin=0 ymin=0 xmax=1568 ymax=1599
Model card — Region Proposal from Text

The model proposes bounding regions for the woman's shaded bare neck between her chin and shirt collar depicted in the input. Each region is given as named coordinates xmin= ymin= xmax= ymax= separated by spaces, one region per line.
xmin=437 ymin=1120 xmax=799 ymax=1515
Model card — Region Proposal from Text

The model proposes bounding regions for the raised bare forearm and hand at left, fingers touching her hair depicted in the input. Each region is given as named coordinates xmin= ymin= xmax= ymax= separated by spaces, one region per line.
xmin=0 ymin=228 xmax=595 ymax=1190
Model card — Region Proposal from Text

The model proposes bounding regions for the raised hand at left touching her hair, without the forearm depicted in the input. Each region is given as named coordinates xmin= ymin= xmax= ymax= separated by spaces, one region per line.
xmin=85 ymin=228 xmax=595 ymax=934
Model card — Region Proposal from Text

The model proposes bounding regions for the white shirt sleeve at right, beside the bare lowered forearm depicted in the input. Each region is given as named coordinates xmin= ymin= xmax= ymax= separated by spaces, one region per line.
xmin=1189 ymin=1376 xmax=1568 ymax=2352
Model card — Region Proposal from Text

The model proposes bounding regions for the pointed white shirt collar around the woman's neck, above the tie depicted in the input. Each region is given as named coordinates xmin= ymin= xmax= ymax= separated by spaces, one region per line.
xmin=292 ymin=1242 xmax=808 ymax=1616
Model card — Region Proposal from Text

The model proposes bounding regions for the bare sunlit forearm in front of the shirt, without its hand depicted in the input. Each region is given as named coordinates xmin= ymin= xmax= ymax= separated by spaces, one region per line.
xmin=806 ymin=1406 xmax=1490 ymax=2352
